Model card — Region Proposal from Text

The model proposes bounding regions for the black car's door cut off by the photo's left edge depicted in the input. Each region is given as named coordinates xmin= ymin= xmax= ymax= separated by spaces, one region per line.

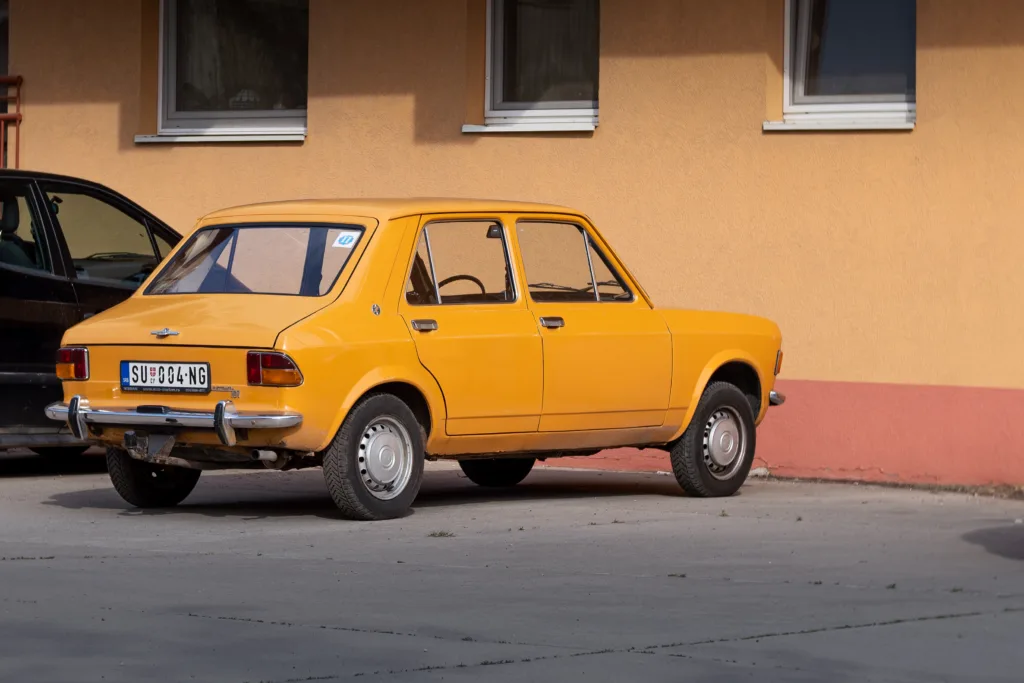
xmin=0 ymin=177 xmax=77 ymax=430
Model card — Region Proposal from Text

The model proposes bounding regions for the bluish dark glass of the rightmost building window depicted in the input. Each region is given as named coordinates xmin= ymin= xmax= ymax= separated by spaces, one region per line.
xmin=797 ymin=0 xmax=916 ymax=101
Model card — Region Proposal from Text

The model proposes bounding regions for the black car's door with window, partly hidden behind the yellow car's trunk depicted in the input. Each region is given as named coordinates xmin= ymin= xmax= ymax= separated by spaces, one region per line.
xmin=39 ymin=179 xmax=178 ymax=318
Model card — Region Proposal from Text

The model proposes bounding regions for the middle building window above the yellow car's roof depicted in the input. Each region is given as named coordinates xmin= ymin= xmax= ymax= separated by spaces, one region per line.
xmin=485 ymin=0 xmax=600 ymax=127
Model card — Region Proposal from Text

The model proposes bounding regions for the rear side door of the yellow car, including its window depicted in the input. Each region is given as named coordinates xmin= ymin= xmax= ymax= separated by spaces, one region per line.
xmin=398 ymin=216 xmax=543 ymax=435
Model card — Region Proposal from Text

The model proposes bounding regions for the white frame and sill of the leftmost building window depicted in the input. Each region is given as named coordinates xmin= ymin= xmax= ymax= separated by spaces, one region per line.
xmin=135 ymin=0 xmax=308 ymax=142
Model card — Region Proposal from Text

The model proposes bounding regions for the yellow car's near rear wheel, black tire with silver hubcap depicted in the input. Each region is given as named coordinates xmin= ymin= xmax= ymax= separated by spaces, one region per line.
xmin=324 ymin=393 xmax=425 ymax=521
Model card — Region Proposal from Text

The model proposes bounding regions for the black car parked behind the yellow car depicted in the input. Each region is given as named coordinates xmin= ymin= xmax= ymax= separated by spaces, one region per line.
xmin=0 ymin=171 xmax=181 ymax=456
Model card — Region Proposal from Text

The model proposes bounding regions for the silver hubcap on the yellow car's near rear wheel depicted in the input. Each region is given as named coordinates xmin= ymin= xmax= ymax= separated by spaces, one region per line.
xmin=358 ymin=416 xmax=413 ymax=501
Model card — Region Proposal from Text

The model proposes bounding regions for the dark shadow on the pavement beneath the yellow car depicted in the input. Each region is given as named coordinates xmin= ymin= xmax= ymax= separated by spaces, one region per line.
xmin=45 ymin=469 xmax=684 ymax=520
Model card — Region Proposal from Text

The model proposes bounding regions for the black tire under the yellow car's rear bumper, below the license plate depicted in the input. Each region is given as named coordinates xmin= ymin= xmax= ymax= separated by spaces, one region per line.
xmin=106 ymin=447 xmax=201 ymax=508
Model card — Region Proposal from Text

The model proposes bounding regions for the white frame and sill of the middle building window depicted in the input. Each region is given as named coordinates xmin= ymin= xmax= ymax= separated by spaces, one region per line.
xmin=463 ymin=0 xmax=600 ymax=133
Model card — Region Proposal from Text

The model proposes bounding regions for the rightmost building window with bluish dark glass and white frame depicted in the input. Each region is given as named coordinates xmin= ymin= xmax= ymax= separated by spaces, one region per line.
xmin=784 ymin=0 xmax=916 ymax=127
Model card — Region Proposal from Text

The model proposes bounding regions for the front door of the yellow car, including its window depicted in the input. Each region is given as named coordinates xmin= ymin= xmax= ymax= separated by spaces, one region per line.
xmin=516 ymin=217 xmax=672 ymax=432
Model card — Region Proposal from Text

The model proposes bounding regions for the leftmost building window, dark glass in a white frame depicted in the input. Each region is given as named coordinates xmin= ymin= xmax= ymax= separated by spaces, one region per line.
xmin=160 ymin=0 xmax=309 ymax=135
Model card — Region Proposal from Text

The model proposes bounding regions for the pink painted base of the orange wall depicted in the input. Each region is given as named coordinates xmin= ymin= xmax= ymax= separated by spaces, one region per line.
xmin=547 ymin=380 xmax=1024 ymax=486
